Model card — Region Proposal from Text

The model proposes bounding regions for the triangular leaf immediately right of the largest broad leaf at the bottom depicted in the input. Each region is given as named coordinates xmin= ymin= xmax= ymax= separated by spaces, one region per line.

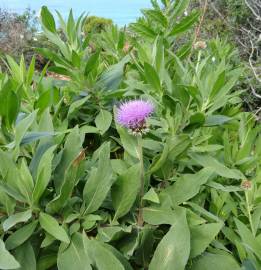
xmin=190 ymin=223 xmax=224 ymax=258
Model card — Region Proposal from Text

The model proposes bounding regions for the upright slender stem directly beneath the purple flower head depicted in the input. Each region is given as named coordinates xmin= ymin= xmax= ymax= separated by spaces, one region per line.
xmin=138 ymin=135 xmax=144 ymax=227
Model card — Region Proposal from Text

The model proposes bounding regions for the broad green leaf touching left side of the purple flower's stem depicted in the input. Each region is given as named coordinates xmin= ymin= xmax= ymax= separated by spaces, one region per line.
xmin=112 ymin=164 xmax=140 ymax=221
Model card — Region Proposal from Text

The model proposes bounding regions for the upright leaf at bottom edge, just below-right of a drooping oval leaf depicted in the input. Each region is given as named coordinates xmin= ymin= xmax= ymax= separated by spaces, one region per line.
xmin=57 ymin=233 xmax=92 ymax=270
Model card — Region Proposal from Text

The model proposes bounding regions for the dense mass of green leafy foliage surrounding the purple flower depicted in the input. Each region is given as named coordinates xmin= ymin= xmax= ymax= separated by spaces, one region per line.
xmin=0 ymin=0 xmax=261 ymax=270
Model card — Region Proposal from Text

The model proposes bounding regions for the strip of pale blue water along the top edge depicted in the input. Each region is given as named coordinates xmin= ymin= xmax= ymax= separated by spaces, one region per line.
xmin=0 ymin=0 xmax=150 ymax=26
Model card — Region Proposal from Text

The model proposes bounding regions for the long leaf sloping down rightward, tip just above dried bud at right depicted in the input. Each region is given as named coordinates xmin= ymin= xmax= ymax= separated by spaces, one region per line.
xmin=190 ymin=153 xmax=246 ymax=180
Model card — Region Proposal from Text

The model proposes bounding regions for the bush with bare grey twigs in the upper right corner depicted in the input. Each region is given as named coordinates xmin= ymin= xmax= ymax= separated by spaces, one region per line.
xmin=191 ymin=0 xmax=261 ymax=111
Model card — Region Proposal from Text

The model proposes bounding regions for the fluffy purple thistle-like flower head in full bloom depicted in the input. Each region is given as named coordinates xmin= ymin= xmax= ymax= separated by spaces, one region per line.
xmin=116 ymin=100 xmax=154 ymax=134
